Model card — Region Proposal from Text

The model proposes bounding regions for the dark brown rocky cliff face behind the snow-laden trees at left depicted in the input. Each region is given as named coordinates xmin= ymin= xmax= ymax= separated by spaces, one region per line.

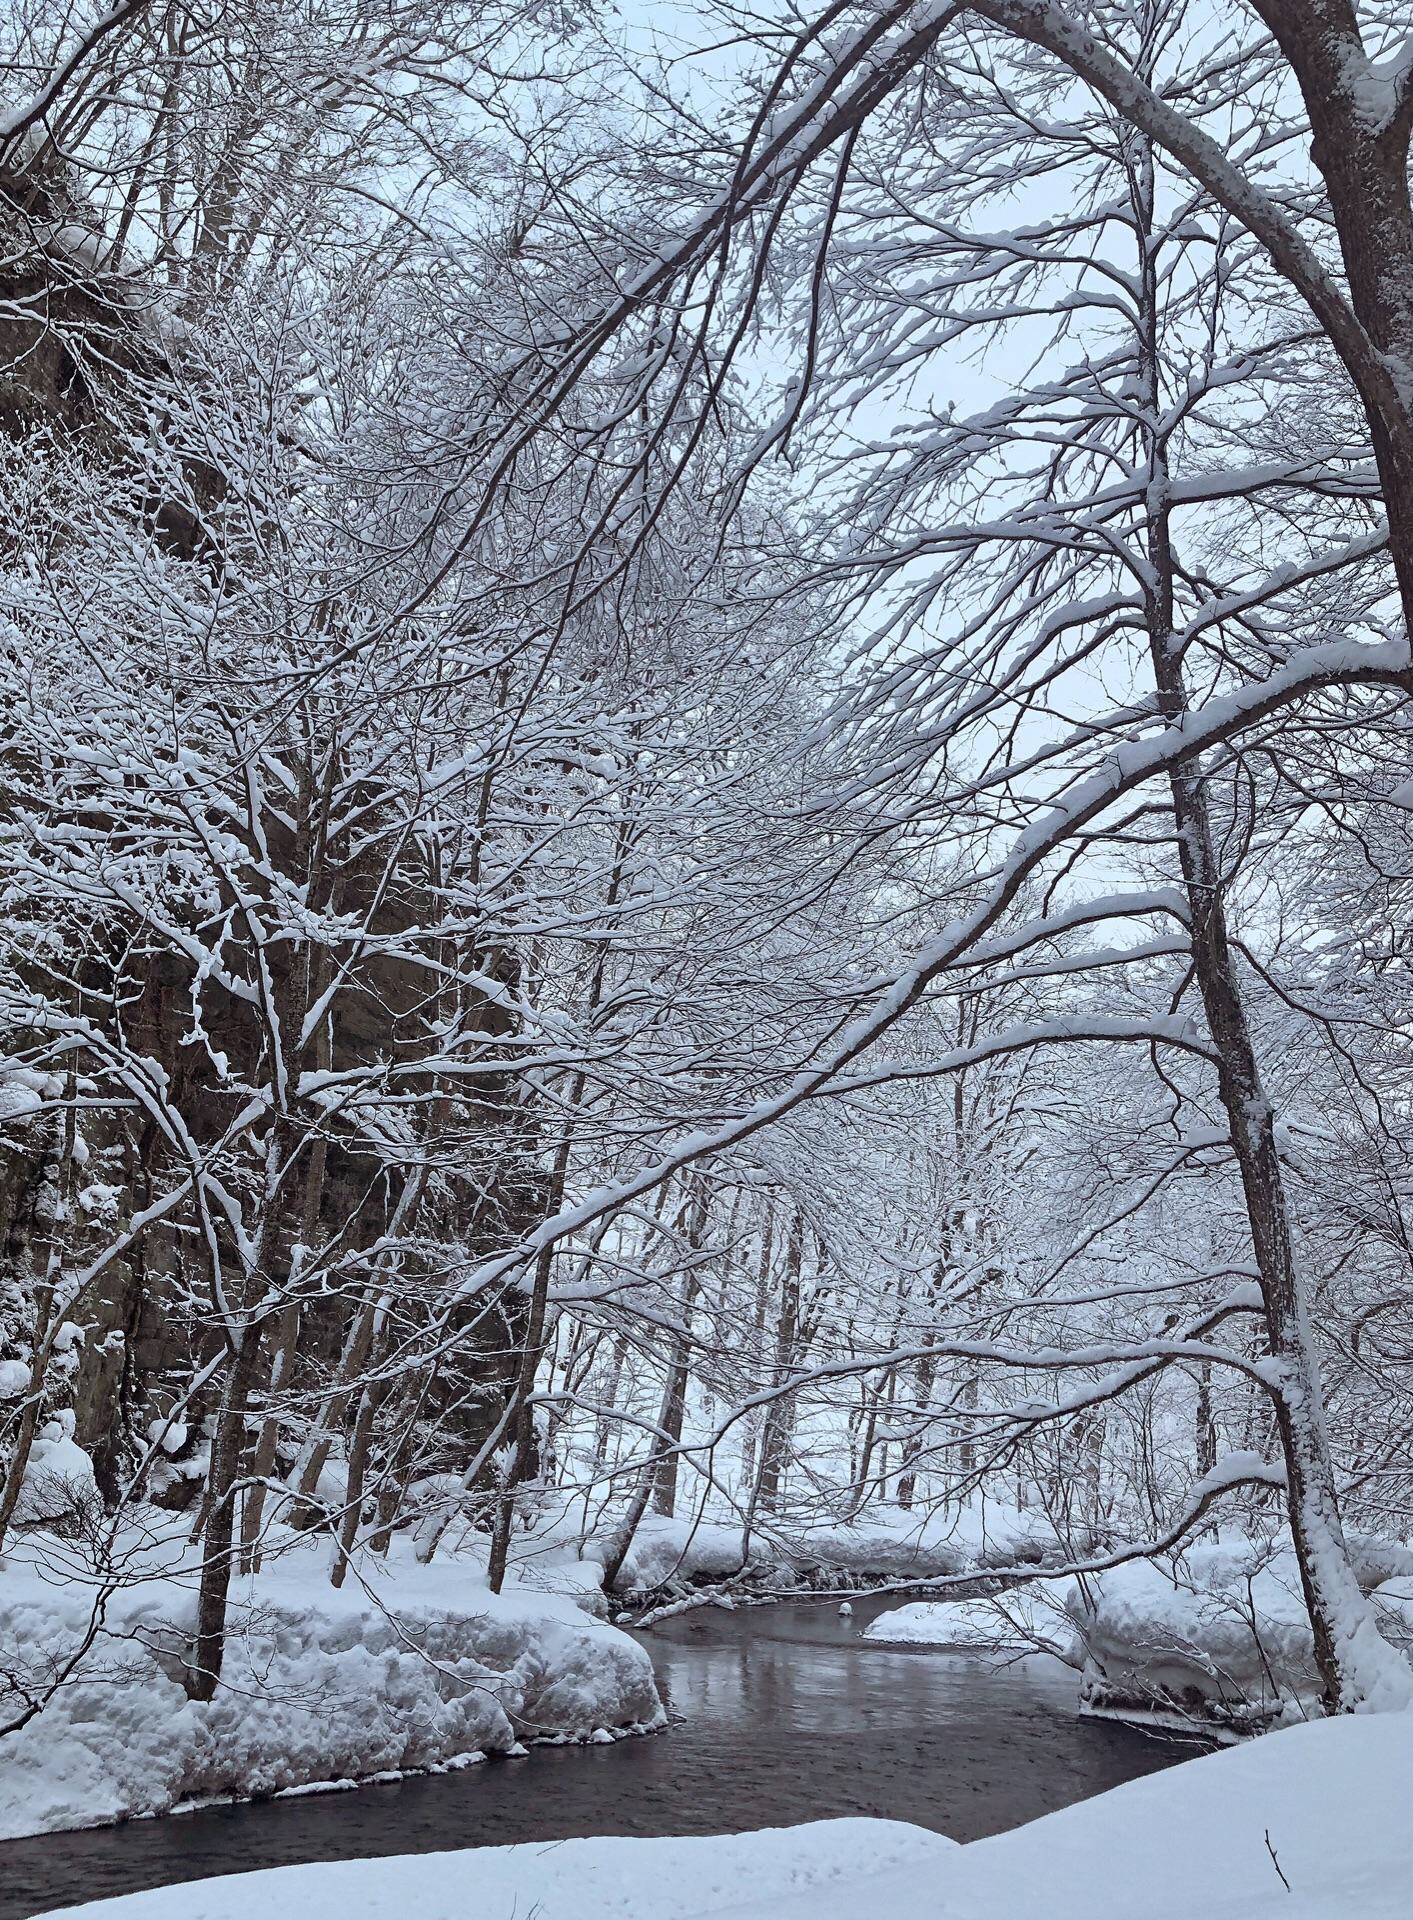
xmin=0 ymin=149 xmax=541 ymax=1528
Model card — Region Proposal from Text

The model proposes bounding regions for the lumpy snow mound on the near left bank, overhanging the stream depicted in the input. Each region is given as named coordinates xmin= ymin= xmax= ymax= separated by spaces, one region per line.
xmin=0 ymin=1544 xmax=662 ymax=1839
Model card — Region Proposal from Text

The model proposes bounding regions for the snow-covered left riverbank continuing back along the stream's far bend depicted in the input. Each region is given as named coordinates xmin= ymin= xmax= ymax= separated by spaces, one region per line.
xmin=0 ymin=1474 xmax=1054 ymax=1839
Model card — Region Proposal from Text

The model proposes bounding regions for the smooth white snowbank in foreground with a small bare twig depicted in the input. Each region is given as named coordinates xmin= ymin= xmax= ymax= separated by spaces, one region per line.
xmin=44 ymin=1713 xmax=1413 ymax=1920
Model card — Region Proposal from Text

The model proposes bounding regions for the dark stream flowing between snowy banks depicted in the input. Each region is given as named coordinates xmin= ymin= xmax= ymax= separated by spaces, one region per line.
xmin=0 ymin=1599 xmax=1194 ymax=1920
